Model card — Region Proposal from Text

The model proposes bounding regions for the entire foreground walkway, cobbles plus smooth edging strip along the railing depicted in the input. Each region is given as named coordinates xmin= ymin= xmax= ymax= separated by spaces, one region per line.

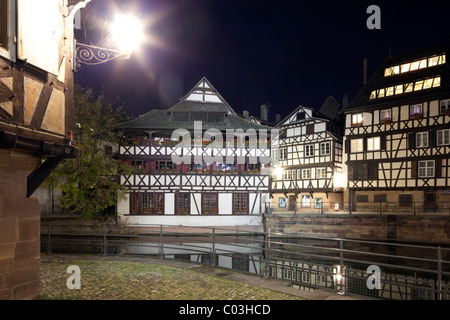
xmin=41 ymin=254 xmax=361 ymax=300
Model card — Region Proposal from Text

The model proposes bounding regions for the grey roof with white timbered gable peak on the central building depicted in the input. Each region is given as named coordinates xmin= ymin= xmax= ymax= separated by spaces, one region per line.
xmin=122 ymin=77 xmax=270 ymax=131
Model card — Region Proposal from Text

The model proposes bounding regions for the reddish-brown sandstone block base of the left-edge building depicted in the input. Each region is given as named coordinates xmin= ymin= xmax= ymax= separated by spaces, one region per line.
xmin=0 ymin=151 xmax=40 ymax=300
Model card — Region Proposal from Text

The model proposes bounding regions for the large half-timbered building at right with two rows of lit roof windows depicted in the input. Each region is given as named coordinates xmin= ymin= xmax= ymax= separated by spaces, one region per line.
xmin=345 ymin=45 xmax=450 ymax=210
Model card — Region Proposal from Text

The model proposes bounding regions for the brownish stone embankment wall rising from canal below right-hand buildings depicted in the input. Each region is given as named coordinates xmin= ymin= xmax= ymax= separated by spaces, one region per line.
xmin=265 ymin=215 xmax=450 ymax=246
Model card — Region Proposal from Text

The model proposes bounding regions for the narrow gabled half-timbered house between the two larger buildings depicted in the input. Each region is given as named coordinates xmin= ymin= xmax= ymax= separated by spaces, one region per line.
xmin=271 ymin=97 xmax=344 ymax=212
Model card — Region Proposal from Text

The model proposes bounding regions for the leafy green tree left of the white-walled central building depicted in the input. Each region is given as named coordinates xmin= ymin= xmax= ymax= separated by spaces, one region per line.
xmin=45 ymin=86 xmax=131 ymax=218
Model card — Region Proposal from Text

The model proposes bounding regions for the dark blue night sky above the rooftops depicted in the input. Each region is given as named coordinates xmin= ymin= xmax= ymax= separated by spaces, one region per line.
xmin=76 ymin=0 xmax=450 ymax=117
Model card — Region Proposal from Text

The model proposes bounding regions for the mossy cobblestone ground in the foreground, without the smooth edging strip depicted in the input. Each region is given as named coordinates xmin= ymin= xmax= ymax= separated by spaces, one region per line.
xmin=41 ymin=256 xmax=302 ymax=300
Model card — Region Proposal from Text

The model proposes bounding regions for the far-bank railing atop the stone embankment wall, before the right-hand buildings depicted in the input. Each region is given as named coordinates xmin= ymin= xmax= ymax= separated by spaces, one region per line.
xmin=265 ymin=199 xmax=450 ymax=216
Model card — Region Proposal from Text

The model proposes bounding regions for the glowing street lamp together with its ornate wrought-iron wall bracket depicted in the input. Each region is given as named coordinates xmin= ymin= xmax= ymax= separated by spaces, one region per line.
xmin=73 ymin=14 xmax=143 ymax=71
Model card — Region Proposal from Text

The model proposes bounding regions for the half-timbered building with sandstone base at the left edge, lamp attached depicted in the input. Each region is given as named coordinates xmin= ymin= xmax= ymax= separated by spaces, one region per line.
xmin=0 ymin=0 xmax=85 ymax=300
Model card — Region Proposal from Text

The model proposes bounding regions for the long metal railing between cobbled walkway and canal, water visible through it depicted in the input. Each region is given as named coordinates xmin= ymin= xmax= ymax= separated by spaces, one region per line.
xmin=41 ymin=224 xmax=450 ymax=300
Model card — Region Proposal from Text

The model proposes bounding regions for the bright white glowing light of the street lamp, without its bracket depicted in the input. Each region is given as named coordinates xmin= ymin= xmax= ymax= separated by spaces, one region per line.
xmin=111 ymin=14 xmax=143 ymax=53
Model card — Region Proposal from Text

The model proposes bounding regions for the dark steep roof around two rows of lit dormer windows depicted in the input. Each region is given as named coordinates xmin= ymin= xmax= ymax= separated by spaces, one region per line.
xmin=345 ymin=43 xmax=450 ymax=110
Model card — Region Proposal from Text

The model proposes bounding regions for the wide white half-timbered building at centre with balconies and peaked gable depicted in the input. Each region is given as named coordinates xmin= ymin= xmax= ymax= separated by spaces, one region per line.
xmin=118 ymin=78 xmax=270 ymax=227
